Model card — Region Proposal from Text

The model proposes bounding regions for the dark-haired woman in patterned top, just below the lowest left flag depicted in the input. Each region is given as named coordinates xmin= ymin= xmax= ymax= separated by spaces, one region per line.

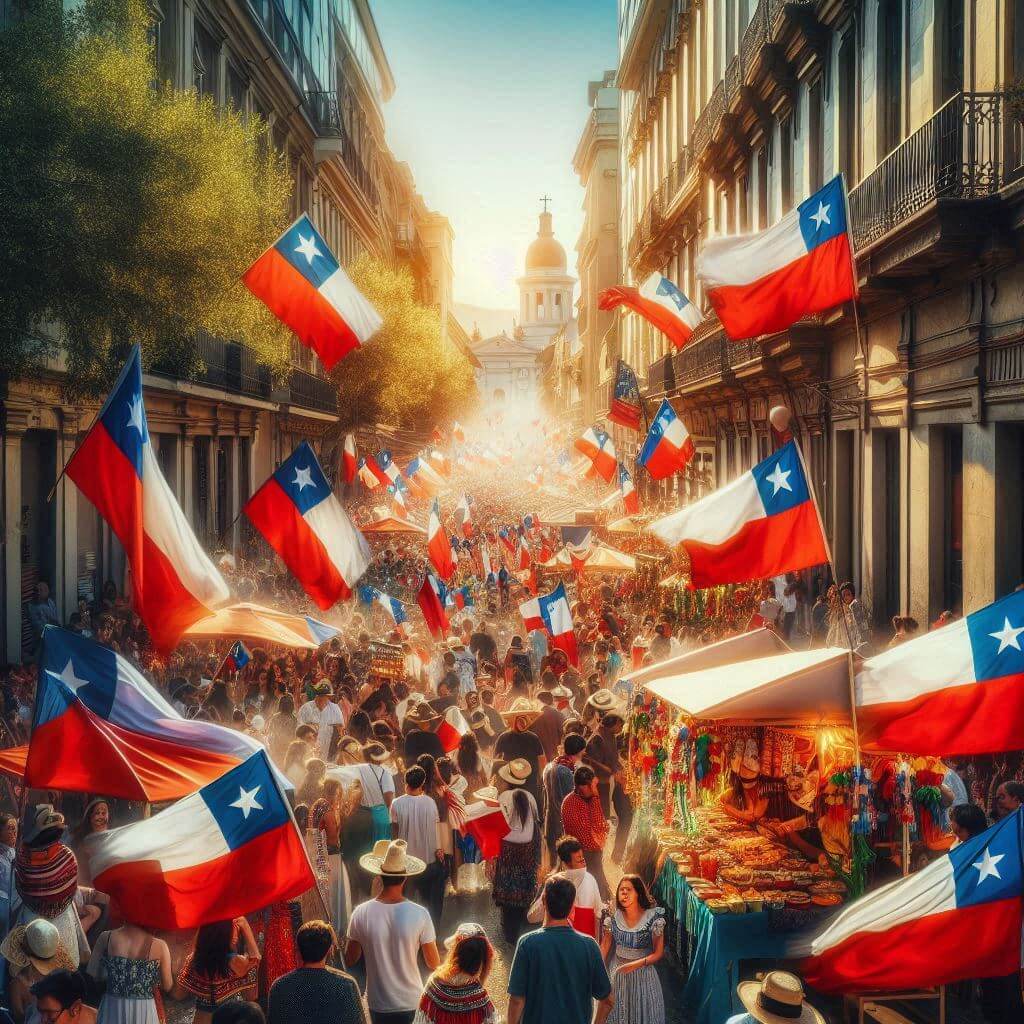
xmin=173 ymin=918 xmax=260 ymax=1024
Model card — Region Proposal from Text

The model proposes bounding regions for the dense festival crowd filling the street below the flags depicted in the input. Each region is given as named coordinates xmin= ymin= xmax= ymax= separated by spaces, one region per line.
xmin=0 ymin=456 xmax=1011 ymax=1024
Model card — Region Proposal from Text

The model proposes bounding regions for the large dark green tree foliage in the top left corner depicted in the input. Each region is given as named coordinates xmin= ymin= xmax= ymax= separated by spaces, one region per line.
xmin=0 ymin=0 xmax=291 ymax=393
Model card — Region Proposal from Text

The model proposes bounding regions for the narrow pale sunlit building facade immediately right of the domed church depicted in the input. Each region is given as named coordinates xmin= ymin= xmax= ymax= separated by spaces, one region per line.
xmin=572 ymin=71 xmax=620 ymax=426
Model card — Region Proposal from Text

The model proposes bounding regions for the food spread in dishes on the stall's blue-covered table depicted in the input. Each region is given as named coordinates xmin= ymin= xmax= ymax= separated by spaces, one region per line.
xmin=655 ymin=805 xmax=846 ymax=914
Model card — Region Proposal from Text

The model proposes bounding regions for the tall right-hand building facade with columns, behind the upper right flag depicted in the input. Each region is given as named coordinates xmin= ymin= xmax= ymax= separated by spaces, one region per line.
xmin=617 ymin=0 xmax=1024 ymax=624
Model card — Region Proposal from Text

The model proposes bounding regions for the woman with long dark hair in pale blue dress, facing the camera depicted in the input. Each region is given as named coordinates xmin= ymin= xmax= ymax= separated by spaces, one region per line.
xmin=601 ymin=874 xmax=665 ymax=1024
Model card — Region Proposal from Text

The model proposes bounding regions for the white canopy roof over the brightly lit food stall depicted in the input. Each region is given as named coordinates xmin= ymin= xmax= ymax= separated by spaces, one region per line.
xmin=644 ymin=634 xmax=853 ymax=725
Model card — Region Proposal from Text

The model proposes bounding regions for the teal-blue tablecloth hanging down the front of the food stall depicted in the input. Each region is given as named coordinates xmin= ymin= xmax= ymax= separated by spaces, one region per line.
xmin=654 ymin=860 xmax=791 ymax=1024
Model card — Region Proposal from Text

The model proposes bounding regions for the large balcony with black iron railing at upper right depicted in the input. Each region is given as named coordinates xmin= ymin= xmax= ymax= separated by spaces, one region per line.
xmin=850 ymin=92 xmax=1022 ymax=272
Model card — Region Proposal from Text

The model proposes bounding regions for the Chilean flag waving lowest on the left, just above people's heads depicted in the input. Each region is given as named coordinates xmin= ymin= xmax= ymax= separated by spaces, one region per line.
xmin=85 ymin=750 xmax=316 ymax=931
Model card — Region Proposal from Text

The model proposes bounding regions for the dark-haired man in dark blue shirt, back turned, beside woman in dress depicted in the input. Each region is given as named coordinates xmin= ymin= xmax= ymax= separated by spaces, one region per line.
xmin=508 ymin=878 xmax=613 ymax=1024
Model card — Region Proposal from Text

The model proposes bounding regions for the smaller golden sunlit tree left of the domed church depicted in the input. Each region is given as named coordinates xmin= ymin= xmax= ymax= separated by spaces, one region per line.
xmin=334 ymin=254 xmax=477 ymax=429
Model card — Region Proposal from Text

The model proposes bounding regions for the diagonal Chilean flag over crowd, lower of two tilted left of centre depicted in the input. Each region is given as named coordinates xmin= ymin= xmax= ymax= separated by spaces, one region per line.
xmin=242 ymin=441 xmax=370 ymax=608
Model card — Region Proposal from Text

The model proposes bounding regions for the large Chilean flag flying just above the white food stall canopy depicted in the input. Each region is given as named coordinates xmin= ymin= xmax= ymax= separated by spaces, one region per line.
xmin=648 ymin=441 xmax=828 ymax=588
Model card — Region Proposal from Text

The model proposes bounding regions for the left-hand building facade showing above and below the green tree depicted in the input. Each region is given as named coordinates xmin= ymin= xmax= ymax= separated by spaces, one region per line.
xmin=0 ymin=0 xmax=456 ymax=660
